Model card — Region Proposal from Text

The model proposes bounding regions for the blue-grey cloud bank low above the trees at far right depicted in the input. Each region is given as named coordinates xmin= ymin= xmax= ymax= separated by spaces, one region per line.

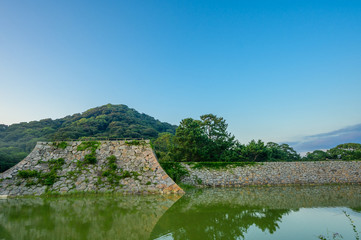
xmin=287 ymin=124 xmax=361 ymax=152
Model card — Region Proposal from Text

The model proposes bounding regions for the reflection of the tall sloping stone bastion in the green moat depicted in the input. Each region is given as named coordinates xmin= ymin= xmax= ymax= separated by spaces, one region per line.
xmin=0 ymin=195 xmax=180 ymax=240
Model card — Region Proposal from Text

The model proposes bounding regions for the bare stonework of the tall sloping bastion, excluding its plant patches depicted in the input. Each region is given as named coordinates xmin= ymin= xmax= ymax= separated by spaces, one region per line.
xmin=0 ymin=141 xmax=182 ymax=196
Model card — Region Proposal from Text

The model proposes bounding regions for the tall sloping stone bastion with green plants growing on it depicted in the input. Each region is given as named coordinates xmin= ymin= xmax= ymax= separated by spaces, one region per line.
xmin=0 ymin=141 xmax=182 ymax=196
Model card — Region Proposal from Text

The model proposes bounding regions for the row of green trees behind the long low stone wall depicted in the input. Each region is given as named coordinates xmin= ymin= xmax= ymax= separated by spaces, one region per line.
xmin=153 ymin=114 xmax=361 ymax=162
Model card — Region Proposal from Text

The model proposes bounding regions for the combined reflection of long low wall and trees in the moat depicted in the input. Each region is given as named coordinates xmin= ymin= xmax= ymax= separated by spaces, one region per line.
xmin=151 ymin=185 xmax=361 ymax=240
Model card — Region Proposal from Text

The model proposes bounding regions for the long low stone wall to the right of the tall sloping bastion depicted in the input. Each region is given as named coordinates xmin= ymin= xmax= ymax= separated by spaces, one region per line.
xmin=182 ymin=161 xmax=361 ymax=187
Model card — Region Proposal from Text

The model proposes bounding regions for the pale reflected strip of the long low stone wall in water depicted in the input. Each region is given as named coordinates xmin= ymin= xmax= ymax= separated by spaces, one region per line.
xmin=182 ymin=185 xmax=361 ymax=211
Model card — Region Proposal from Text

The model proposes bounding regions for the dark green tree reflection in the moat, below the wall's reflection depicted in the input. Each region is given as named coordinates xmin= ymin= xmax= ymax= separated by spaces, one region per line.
xmin=151 ymin=196 xmax=290 ymax=240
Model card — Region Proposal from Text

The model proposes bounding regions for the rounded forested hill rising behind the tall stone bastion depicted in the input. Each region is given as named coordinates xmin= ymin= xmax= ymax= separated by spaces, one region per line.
xmin=0 ymin=104 xmax=177 ymax=172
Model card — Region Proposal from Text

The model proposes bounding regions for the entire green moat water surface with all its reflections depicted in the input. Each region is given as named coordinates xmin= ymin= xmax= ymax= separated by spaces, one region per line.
xmin=0 ymin=185 xmax=361 ymax=240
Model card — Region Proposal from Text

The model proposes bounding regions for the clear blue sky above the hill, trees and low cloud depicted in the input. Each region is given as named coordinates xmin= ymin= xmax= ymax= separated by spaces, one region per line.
xmin=0 ymin=0 xmax=361 ymax=148
